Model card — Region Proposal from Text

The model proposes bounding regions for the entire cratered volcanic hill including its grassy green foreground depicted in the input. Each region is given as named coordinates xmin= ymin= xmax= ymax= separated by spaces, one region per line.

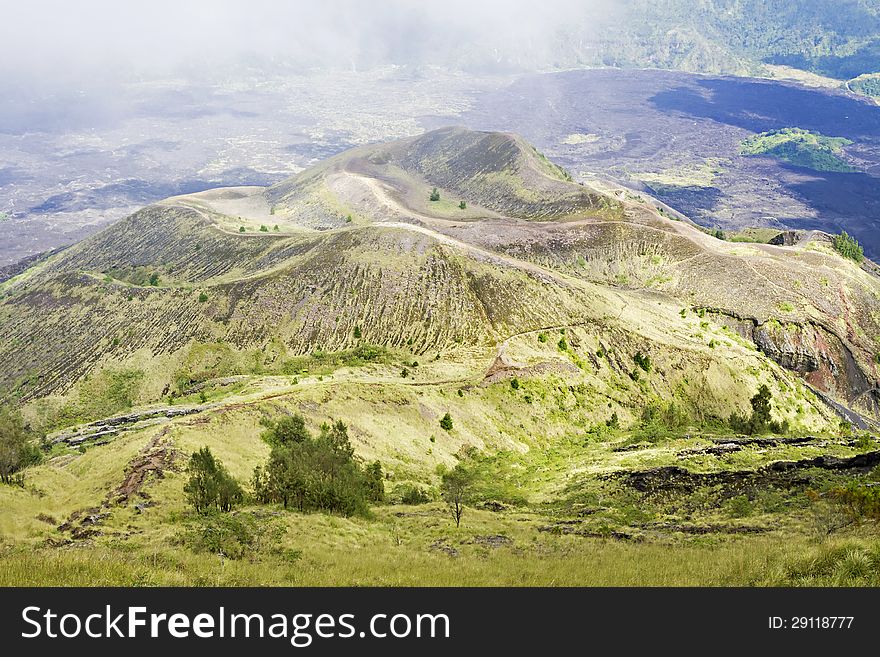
xmin=0 ymin=128 xmax=880 ymax=585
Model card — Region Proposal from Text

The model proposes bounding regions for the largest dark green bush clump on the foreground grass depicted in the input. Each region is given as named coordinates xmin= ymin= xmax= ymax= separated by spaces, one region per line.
xmin=253 ymin=415 xmax=385 ymax=516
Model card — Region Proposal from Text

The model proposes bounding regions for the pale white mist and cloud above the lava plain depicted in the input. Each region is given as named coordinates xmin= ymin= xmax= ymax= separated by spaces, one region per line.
xmin=0 ymin=0 xmax=619 ymax=85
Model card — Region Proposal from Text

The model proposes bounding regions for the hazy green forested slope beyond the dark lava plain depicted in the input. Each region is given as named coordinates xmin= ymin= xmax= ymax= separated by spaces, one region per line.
xmin=474 ymin=0 xmax=880 ymax=80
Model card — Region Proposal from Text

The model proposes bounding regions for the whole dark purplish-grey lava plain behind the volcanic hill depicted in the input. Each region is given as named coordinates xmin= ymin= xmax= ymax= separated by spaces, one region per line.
xmin=0 ymin=69 xmax=880 ymax=266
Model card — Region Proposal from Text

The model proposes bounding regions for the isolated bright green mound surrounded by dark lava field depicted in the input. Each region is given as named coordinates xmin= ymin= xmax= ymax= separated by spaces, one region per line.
xmin=740 ymin=128 xmax=858 ymax=173
